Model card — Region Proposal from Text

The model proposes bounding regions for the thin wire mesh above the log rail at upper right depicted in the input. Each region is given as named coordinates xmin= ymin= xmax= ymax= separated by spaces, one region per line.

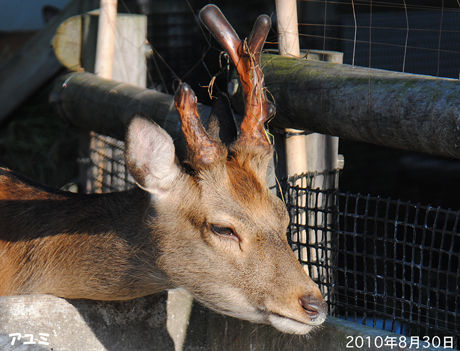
xmin=298 ymin=0 xmax=460 ymax=78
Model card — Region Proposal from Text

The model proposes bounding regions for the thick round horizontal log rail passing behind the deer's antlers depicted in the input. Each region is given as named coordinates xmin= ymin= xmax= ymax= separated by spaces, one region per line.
xmin=51 ymin=55 xmax=460 ymax=158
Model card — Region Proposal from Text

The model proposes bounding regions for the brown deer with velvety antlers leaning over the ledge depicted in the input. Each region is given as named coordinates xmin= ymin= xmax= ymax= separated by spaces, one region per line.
xmin=0 ymin=5 xmax=326 ymax=334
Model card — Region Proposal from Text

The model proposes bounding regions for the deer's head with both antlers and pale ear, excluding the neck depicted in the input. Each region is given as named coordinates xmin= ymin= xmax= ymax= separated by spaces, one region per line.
xmin=126 ymin=5 xmax=325 ymax=334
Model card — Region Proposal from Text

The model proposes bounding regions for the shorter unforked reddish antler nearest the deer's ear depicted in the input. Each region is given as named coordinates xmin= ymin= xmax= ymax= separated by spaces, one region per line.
xmin=174 ymin=83 xmax=227 ymax=169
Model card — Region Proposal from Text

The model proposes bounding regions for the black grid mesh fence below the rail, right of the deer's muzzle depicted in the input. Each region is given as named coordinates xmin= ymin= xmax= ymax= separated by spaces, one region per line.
xmin=286 ymin=174 xmax=460 ymax=348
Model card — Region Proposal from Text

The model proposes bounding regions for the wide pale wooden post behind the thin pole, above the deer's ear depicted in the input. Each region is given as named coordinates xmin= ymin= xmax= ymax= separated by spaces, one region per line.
xmin=80 ymin=11 xmax=147 ymax=193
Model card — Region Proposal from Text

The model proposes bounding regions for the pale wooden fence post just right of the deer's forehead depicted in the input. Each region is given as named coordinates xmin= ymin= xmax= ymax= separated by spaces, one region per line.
xmin=276 ymin=0 xmax=342 ymax=300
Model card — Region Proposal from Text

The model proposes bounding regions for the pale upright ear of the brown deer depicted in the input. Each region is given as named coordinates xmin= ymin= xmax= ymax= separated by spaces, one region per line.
xmin=125 ymin=115 xmax=180 ymax=197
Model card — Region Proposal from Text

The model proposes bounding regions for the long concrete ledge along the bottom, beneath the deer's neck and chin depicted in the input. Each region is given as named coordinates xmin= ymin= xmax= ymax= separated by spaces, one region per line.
xmin=0 ymin=293 xmax=448 ymax=351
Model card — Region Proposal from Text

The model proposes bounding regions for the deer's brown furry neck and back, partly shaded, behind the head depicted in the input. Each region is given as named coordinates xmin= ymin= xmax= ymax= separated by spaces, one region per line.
xmin=0 ymin=169 xmax=169 ymax=300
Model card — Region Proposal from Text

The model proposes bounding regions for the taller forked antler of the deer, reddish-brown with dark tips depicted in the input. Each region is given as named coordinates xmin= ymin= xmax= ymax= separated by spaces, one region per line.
xmin=200 ymin=5 xmax=274 ymax=153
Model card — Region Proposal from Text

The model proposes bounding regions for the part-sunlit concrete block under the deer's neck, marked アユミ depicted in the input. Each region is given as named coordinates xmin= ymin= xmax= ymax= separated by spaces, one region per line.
xmin=0 ymin=293 xmax=174 ymax=351
